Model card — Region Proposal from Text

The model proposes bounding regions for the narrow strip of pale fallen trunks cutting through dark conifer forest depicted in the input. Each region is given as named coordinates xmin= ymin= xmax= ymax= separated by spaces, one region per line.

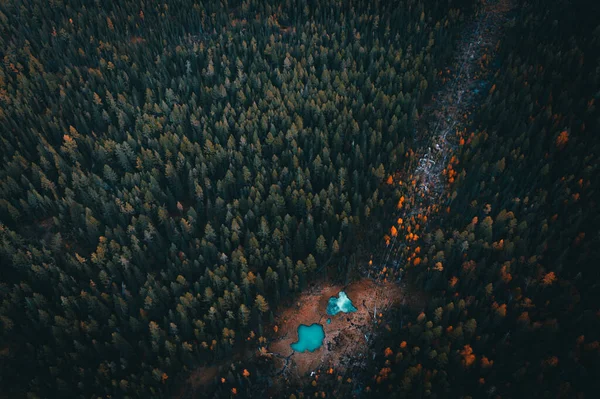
xmin=368 ymin=0 xmax=513 ymax=310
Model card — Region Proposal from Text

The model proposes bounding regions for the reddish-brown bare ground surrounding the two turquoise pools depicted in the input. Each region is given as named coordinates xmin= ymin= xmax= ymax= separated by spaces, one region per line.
xmin=268 ymin=279 xmax=402 ymax=380
